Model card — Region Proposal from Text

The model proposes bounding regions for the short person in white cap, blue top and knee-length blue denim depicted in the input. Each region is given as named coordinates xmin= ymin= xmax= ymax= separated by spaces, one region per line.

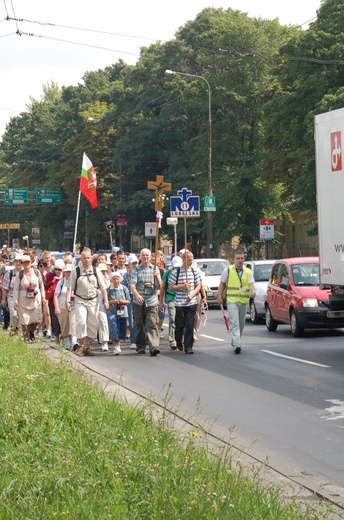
xmin=107 ymin=271 xmax=130 ymax=356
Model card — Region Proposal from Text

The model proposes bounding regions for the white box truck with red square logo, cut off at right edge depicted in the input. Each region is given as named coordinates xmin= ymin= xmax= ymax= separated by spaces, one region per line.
xmin=315 ymin=104 xmax=344 ymax=312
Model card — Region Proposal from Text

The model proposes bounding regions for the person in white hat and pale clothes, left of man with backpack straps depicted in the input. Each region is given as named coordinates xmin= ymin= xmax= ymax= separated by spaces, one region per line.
xmin=54 ymin=260 xmax=76 ymax=350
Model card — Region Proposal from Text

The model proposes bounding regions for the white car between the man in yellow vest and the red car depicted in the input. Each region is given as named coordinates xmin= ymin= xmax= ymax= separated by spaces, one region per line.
xmin=244 ymin=260 xmax=275 ymax=324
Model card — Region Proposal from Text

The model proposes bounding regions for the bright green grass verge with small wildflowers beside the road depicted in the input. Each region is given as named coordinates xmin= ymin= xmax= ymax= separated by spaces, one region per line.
xmin=0 ymin=333 xmax=338 ymax=520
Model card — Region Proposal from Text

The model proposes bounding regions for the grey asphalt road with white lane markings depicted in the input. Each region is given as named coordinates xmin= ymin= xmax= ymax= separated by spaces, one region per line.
xmin=65 ymin=309 xmax=344 ymax=502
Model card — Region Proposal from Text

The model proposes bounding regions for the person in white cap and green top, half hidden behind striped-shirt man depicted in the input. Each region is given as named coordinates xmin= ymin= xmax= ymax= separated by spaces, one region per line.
xmin=159 ymin=256 xmax=183 ymax=350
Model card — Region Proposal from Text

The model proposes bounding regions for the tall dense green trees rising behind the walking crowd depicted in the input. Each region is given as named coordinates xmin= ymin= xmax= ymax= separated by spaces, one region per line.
xmin=0 ymin=0 xmax=344 ymax=249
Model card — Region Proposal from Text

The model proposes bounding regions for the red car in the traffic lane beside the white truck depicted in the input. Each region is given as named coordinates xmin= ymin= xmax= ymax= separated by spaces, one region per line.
xmin=265 ymin=257 xmax=344 ymax=337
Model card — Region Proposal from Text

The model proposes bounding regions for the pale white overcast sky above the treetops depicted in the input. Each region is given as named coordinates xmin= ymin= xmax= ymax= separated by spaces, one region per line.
xmin=0 ymin=0 xmax=322 ymax=136
